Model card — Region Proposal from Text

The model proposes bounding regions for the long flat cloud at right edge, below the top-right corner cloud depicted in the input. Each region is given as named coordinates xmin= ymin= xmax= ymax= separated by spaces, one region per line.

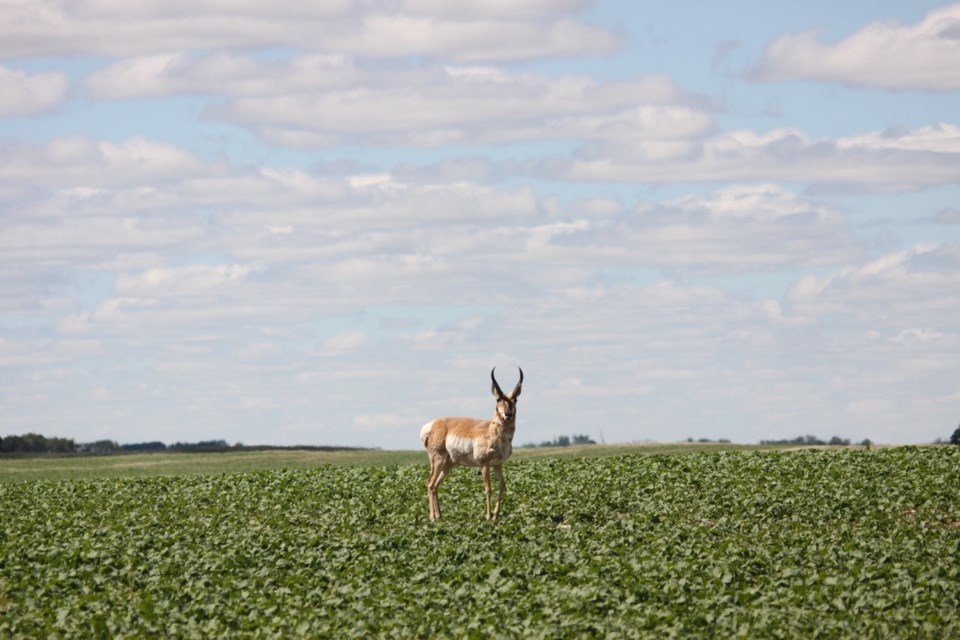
xmin=560 ymin=124 xmax=960 ymax=191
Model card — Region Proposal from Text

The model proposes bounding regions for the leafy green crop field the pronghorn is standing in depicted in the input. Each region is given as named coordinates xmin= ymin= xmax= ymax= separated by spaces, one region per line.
xmin=0 ymin=447 xmax=960 ymax=638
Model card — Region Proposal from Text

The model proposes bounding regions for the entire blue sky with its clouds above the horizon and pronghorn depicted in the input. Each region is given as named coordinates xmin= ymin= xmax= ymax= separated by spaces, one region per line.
xmin=0 ymin=0 xmax=960 ymax=448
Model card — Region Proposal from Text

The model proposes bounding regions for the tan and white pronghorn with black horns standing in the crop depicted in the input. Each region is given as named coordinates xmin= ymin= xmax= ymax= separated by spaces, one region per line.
xmin=420 ymin=367 xmax=523 ymax=521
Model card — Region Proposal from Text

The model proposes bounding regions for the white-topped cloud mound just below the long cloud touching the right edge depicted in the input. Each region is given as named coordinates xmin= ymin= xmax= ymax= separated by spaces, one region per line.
xmin=502 ymin=185 xmax=862 ymax=281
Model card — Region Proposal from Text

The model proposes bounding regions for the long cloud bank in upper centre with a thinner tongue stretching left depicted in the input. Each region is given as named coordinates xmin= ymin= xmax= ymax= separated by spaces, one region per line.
xmin=85 ymin=54 xmax=714 ymax=148
